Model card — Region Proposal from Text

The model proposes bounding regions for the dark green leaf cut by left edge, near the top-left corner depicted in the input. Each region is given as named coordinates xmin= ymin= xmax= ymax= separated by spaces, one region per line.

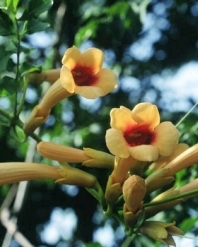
xmin=0 ymin=9 xmax=14 ymax=36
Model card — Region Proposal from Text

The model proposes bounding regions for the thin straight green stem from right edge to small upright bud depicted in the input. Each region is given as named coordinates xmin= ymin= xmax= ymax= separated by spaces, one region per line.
xmin=143 ymin=189 xmax=198 ymax=208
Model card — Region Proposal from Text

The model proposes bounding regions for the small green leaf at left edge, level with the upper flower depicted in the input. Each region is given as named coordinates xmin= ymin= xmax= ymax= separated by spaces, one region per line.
xmin=0 ymin=76 xmax=15 ymax=96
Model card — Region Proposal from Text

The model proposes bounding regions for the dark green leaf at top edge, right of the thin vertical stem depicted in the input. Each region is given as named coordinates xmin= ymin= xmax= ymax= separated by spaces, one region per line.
xmin=20 ymin=0 xmax=53 ymax=20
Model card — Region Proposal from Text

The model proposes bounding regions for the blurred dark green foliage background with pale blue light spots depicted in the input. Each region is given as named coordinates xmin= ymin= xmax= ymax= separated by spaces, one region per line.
xmin=0 ymin=0 xmax=198 ymax=247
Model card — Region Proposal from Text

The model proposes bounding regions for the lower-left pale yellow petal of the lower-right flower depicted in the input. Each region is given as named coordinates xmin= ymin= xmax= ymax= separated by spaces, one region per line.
xmin=106 ymin=129 xmax=129 ymax=158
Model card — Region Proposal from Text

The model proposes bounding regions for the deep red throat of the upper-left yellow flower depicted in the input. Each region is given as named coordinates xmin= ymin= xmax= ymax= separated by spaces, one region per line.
xmin=71 ymin=65 xmax=98 ymax=86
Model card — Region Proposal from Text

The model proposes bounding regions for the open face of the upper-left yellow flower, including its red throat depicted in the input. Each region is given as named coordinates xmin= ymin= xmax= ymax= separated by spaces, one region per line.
xmin=60 ymin=46 xmax=117 ymax=99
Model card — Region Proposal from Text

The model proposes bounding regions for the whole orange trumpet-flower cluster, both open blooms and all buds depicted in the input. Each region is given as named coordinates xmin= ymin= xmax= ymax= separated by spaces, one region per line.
xmin=0 ymin=47 xmax=198 ymax=246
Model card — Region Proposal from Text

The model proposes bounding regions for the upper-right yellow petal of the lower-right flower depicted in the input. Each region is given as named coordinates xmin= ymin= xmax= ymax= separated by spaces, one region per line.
xmin=132 ymin=102 xmax=160 ymax=128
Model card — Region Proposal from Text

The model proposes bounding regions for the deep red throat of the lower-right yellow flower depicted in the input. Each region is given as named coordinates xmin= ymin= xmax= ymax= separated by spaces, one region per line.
xmin=124 ymin=124 xmax=155 ymax=147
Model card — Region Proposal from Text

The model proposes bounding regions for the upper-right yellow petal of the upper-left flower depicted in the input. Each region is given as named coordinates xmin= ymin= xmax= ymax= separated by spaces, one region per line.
xmin=82 ymin=48 xmax=104 ymax=74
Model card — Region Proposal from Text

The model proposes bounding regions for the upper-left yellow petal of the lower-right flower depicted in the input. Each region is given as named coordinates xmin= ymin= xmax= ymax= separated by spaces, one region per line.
xmin=110 ymin=106 xmax=136 ymax=131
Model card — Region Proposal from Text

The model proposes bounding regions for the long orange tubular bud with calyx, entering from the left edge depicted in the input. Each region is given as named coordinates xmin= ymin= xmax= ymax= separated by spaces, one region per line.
xmin=0 ymin=162 xmax=99 ymax=189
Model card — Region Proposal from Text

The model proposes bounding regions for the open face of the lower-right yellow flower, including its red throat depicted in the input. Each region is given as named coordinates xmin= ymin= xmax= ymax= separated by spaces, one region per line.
xmin=106 ymin=102 xmax=179 ymax=161
